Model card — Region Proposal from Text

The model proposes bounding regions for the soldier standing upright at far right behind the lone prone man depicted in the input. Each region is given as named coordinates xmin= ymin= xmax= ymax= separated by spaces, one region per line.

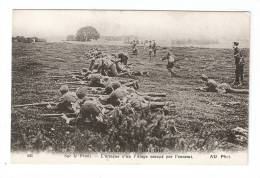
xmin=233 ymin=42 xmax=245 ymax=85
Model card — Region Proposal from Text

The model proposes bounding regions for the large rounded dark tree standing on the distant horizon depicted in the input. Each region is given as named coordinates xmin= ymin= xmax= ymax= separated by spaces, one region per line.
xmin=76 ymin=26 xmax=100 ymax=41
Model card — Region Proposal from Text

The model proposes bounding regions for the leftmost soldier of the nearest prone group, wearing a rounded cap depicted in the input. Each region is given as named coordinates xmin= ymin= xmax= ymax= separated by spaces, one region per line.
xmin=47 ymin=85 xmax=77 ymax=113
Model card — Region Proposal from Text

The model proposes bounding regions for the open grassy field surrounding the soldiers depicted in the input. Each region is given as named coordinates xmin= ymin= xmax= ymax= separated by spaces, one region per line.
xmin=11 ymin=43 xmax=249 ymax=152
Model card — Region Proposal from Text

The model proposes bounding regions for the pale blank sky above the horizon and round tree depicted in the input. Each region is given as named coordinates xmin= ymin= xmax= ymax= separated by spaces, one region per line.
xmin=13 ymin=10 xmax=250 ymax=41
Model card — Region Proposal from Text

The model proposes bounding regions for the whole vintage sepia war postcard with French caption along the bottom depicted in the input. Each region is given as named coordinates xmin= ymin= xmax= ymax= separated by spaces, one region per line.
xmin=10 ymin=9 xmax=250 ymax=165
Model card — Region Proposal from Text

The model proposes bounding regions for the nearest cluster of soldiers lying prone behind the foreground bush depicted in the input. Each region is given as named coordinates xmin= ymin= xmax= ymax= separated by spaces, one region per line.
xmin=48 ymin=73 xmax=169 ymax=122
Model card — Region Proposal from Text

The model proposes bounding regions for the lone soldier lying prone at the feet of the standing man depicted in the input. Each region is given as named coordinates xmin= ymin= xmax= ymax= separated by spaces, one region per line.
xmin=197 ymin=74 xmax=249 ymax=94
